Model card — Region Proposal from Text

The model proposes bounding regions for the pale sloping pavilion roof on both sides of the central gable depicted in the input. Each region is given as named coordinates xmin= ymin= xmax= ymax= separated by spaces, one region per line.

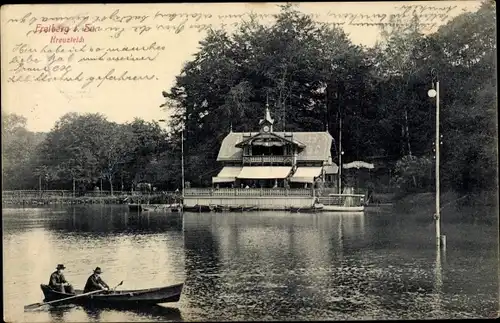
xmin=217 ymin=131 xmax=333 ymax=162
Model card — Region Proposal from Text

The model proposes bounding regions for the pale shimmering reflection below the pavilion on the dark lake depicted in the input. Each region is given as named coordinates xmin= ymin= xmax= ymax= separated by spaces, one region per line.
xmin=184 ymin=212 xmax=372 ymax=306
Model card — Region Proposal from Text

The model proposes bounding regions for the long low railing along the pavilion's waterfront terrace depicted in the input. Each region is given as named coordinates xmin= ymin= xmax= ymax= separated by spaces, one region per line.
xmin=184 ymin=188 xmax=313 ymax=197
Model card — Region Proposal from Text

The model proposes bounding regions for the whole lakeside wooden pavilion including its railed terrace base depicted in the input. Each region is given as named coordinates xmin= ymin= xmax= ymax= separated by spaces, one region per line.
xmin=184 ymin=106 xmax=362 ymax=211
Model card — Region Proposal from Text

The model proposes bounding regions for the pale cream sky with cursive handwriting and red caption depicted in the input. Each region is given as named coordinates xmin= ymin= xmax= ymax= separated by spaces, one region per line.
xmin=1 ymin=1 xmax=480 ymax=131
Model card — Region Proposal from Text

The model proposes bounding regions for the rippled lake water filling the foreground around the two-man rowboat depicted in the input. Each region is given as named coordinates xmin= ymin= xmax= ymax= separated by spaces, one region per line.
xmin=2 ymin=205 xmax=499 ymax=322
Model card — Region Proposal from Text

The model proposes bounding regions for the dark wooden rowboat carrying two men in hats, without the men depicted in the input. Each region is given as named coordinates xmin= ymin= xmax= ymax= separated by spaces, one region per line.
xmin=40 ymin=283 xmax=184 ymax=306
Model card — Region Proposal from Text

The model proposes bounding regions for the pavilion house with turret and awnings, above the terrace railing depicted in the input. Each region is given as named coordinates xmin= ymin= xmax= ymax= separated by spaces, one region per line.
xmin=212 ymin=107 xmax=338 ymax=188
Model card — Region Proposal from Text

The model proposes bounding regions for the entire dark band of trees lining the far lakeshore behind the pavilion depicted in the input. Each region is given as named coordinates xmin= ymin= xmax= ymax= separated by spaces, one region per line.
xmin=2 ymin=2 xmax=497 ymax=195
